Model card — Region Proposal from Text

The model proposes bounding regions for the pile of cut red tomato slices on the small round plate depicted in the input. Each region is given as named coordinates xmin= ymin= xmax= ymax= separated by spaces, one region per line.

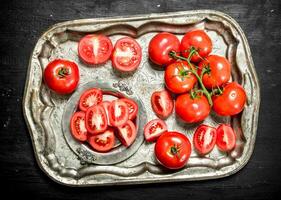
xmin=70 ymin=88 xmax=138 ymax=152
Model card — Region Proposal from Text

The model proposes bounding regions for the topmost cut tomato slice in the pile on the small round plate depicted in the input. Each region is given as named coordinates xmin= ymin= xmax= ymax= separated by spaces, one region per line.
xmin=79 ymin=88 xmax=103 ymax=111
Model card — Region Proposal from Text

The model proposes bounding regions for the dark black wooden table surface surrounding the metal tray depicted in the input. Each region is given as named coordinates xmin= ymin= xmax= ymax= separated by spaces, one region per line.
xmin=0 ymin=0 xmax=281 ymax=199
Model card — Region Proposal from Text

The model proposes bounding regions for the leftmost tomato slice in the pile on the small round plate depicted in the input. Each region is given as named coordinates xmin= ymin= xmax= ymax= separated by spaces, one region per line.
xmin=70 ymin=111 xmax=87 ymax=141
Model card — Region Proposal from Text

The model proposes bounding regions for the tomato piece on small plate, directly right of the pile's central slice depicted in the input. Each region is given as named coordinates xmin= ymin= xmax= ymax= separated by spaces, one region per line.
xmin=108 ymin=99 xmax=129 ymax=127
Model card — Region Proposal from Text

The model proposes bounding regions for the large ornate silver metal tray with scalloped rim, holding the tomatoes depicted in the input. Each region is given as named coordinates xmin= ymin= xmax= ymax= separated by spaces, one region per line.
xmin=23 ymin=10 xmax=260 ymax=186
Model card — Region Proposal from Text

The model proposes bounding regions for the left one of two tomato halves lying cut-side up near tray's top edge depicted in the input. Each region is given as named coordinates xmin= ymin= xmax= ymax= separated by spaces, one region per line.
xmin=78 ymin=34 xmax=113 ymax=65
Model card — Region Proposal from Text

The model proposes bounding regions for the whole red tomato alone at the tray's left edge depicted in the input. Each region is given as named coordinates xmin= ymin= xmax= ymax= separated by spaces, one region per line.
xmin=44 ymin=59 xmax=79 ymax=94
